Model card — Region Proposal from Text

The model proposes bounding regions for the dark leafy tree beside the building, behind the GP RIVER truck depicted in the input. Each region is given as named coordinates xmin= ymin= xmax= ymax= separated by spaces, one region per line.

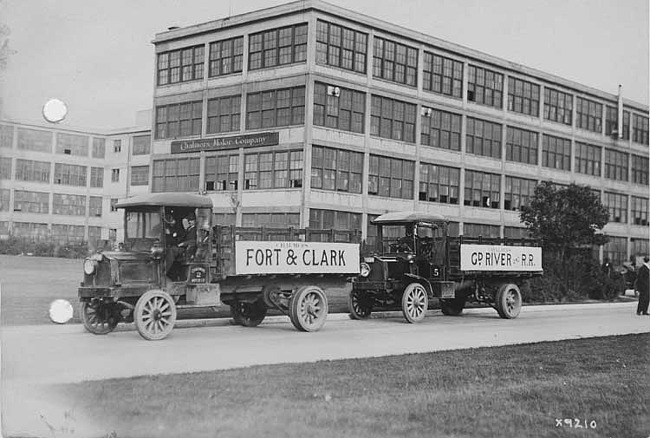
xmin=519 ymin=181 xmax=609 ymax=259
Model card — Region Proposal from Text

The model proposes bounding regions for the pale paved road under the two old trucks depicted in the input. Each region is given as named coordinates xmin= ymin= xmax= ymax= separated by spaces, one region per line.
xmin=2 ymin=302 xmax=650 ymax=438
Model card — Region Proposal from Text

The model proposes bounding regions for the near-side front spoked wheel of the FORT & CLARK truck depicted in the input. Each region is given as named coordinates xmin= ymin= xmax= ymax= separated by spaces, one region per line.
xmin=133 ymin=290 xmax=176 ymax=341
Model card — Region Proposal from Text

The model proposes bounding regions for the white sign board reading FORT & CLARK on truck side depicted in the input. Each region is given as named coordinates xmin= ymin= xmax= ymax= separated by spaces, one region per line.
xmin=235 ymin=241 xmax=359 ymax=275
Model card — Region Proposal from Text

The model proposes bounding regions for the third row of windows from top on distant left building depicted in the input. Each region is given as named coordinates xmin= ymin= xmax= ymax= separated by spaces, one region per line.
xmin=0 ymin=189 xmax=102 ymax=217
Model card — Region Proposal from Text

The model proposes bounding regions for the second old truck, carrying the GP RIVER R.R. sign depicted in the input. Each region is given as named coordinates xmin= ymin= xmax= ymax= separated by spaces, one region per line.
xmin=348 ymin=211 xmax=543 ymax=323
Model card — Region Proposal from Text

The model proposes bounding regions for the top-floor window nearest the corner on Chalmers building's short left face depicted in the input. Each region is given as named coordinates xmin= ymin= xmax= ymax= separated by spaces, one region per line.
xmin=248 ymin=24 xmax=307 ymax=70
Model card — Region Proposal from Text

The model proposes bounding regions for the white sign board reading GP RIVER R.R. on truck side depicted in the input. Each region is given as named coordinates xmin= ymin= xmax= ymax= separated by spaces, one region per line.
xmin=460 ymin=244 xmax=542 ymax=272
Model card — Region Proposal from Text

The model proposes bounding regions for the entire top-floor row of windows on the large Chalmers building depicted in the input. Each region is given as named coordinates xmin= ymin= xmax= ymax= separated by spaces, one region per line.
xmin=157 ymin=20 xmax=648 ymax=144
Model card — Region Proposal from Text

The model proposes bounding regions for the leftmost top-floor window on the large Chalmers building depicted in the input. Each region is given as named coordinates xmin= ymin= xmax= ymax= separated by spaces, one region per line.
xmin=157 ymin=45 xmax=205 ymax=86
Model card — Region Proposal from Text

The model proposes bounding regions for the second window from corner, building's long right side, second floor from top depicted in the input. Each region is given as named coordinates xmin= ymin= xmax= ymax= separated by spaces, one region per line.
xmin=370 ymin=96 xmax=416 ymax=143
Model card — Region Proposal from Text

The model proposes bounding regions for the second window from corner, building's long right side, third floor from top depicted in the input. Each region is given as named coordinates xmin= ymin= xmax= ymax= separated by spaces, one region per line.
xmin=368 ymin=155 xmax=415 ymax=199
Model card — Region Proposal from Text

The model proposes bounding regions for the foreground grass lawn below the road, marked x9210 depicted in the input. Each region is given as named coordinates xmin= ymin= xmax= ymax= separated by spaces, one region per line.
xmin=56 ymin=334 xmax=650 ymax=438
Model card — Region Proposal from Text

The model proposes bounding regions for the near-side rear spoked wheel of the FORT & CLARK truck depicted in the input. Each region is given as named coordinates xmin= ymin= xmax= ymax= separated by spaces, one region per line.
xmin=289 ymin=286 xmax=328 ymax=332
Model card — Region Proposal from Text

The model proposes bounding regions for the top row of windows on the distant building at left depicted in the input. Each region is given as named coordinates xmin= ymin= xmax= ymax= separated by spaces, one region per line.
xmin=0 ymin=125 xmax=151 ymax=158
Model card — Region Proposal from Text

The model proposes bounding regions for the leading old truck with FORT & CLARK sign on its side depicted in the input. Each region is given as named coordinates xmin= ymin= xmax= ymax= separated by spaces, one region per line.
xmin=78 ymin=193 xmax=360 ymax=340
